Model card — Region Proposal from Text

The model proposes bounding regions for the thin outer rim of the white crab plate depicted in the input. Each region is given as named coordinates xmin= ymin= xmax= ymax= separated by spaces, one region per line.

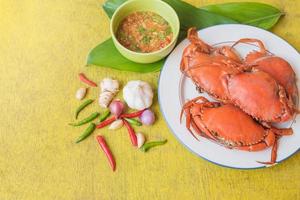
xmin=157 ymin=24 xmax=300 ymax=170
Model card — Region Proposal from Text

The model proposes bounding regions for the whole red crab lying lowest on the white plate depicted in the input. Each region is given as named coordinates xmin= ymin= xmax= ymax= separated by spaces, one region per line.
xmin=183 ymin=97 xmax=292 ymax=163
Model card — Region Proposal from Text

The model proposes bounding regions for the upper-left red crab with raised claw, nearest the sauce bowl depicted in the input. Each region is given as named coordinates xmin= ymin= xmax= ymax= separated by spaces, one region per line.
xmin=180 ymin=28 xmax=241 ymax=101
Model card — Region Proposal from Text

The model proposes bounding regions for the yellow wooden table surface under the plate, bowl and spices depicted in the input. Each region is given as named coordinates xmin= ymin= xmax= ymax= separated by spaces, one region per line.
xmin=0 ymin=0 xmax=300 ymax=200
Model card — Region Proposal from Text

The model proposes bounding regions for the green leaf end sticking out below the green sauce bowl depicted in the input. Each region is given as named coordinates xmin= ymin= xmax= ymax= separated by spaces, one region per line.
xmin=87 ymin=39 xmax=164 ymax=73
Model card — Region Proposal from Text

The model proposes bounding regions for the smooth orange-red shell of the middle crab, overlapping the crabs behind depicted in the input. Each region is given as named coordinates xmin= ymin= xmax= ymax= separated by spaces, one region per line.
xmin=227 ymin=70 xmax=294 ymax=122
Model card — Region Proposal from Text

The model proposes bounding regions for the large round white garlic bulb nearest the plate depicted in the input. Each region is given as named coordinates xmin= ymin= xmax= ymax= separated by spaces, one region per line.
xmin=123 ymin=80 xmax=153 ymax=110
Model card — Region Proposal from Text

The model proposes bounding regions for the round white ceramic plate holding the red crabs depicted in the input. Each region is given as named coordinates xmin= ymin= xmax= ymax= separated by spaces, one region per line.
xmin=158 ymin=25 xmax=300 ymax=169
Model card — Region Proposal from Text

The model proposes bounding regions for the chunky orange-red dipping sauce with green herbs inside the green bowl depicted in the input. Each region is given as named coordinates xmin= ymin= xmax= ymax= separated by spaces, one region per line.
xmin=116 ymin=11 xmax=173 ymax=53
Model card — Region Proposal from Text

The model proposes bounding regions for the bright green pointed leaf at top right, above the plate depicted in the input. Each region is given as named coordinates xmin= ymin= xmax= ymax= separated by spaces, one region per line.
xmin=200 ymin=2 xmax=284 ymax=29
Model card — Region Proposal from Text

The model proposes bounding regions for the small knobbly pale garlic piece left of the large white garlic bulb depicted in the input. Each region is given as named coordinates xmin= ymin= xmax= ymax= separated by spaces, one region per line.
xmin=99 ymin=78 xmax=119 ymax=108
